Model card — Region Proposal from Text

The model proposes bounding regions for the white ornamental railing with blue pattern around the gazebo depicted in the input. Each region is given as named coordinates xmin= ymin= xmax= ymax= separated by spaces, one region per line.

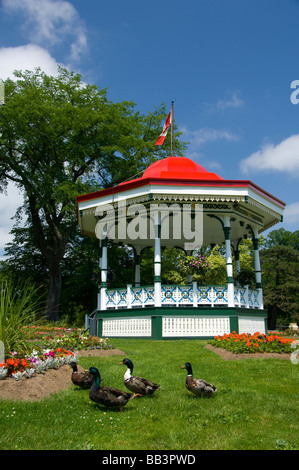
xmin=100 ymin=282 xmax=262 ymax=310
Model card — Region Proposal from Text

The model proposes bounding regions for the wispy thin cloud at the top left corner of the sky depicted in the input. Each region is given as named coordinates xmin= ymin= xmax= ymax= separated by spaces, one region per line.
xmin=2 ymin=0 xmax=87 ymax=60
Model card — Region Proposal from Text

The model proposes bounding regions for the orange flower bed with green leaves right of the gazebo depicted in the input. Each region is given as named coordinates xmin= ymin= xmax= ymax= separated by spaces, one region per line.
xmin=209 ymin=332 xmax=294 ymax=354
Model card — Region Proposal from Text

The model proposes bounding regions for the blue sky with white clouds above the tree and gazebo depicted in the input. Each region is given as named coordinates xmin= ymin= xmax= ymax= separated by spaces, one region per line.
xmin=0 ymin=0 xmax=299 ymax=255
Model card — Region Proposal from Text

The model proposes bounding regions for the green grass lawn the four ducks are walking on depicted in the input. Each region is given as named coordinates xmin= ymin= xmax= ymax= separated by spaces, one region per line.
xmin=0 ymin=339 xmax=299 ymax=451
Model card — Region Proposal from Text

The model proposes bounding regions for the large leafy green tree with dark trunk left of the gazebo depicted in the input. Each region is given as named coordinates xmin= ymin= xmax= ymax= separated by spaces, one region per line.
xmin=0 ymin=69 xmax=185 ymax=320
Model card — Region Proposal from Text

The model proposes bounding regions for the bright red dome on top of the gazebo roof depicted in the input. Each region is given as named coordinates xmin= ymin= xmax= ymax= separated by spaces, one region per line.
xmin=141 ymin=157 xmax=223 ymax=180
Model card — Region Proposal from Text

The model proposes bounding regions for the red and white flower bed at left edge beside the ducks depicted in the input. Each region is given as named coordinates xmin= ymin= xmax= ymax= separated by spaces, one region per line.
xmin=0 ymin=348 xmax=78 ymax=380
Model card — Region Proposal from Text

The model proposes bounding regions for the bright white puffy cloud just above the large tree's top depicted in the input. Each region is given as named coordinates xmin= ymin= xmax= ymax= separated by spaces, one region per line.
xmin=0 ymin=44 xmax=58 ymax=80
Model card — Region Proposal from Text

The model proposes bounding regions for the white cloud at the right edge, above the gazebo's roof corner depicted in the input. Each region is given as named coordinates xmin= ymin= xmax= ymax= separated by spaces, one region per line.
xmin=240 ymin=134 xmax=299 ymax=177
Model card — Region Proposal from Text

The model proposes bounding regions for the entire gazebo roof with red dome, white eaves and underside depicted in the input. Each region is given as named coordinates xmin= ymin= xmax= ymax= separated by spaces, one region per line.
xmin=77 ymin=157 xmax=285 ymax=247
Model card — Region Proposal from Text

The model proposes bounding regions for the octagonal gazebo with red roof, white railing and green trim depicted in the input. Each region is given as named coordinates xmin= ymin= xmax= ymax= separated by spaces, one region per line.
xmin=77 ymin=156 xmax=285 ymax=339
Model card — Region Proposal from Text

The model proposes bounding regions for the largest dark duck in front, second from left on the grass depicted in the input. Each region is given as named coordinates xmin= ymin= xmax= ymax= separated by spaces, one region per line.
xmin=89 ymin=367 xmax=136 ymax=412
